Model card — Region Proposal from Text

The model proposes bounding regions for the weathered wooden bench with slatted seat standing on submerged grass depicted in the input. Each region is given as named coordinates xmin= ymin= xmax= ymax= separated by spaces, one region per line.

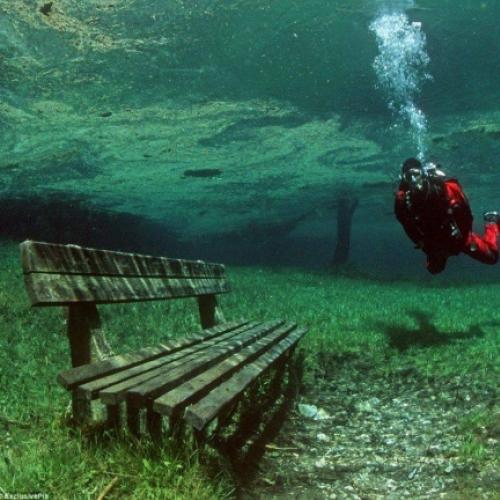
xmin=21 ymin=241 xmax=306 ymax=435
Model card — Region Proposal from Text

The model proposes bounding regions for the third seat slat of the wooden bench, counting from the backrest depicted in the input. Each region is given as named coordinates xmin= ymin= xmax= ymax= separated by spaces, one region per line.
xmin=99 ymin=321 xmax=283 ymax=404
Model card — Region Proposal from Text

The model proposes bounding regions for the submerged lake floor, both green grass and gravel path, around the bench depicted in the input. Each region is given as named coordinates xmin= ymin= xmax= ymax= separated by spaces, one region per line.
xmin=0 ymin=243 xmax=500 ymax=498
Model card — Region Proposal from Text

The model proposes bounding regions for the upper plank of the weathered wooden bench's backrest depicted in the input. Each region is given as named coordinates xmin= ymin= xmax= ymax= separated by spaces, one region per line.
xmin=20 ymin=240 xmax=225 ymax=278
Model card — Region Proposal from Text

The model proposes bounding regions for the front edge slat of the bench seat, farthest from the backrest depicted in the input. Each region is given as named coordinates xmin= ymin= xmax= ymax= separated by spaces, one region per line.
xmin=184 ymin=328 xmax=307 ymax=431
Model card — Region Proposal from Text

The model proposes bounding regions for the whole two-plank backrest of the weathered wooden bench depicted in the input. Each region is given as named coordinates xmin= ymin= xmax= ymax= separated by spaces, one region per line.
xmin=21 ymin=241 xmax=229 ymax=306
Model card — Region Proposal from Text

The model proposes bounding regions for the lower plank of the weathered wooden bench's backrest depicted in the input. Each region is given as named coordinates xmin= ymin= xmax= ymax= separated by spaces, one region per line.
xmin=24 ymin=273 xmax=229 ymax=306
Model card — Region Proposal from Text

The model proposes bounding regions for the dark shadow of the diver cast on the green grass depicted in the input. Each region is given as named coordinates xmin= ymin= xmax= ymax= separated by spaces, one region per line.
xmin=377 ymin=309 xmax=490 ymax=351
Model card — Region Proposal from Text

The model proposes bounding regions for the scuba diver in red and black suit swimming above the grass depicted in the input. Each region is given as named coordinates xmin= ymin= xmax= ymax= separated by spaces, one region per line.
xmin=394 ymin=158 xmax=500 ymax=274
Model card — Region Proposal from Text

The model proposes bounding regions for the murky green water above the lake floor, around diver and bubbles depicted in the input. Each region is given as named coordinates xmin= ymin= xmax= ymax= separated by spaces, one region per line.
xmin=0 ymin=0 xmax=500 ymax=278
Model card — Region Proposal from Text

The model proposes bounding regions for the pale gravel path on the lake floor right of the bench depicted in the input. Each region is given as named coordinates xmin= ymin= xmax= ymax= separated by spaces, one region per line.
xmin=241 ymin=359 xmax=500 ymax=500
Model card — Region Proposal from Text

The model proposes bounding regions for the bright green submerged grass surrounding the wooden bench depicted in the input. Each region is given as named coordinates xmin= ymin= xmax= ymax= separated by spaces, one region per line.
xmin=0 ymin=239 xmax=500 ymax=499
